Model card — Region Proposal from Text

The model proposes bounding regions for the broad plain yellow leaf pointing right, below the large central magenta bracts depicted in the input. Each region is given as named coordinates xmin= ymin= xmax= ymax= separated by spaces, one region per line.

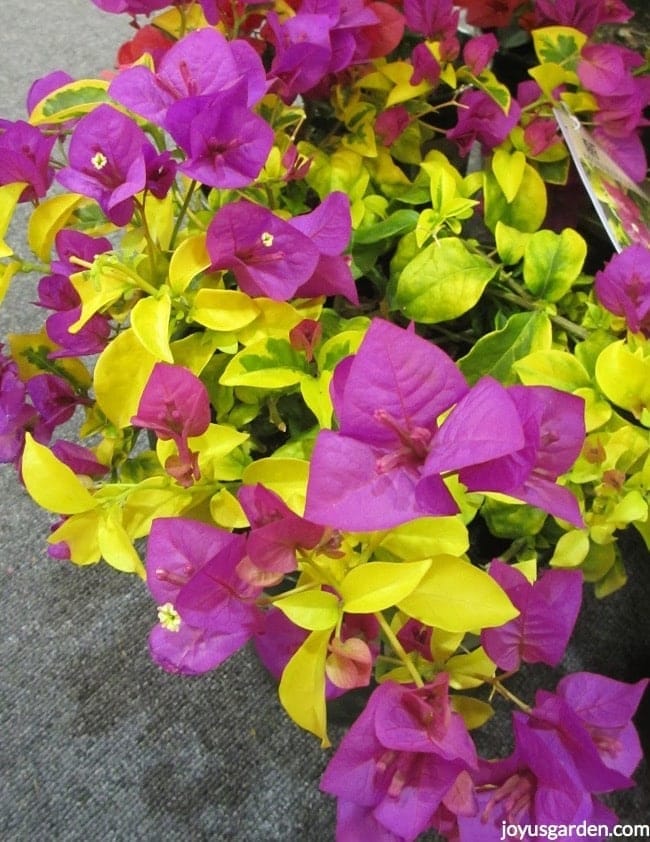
xmin=398 ymin=555 xmax=519 ymax=631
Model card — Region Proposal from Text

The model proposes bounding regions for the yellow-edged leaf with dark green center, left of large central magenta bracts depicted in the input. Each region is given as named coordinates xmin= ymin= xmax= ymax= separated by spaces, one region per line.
xmin=219 ymin=337 xmax=310 ymax=389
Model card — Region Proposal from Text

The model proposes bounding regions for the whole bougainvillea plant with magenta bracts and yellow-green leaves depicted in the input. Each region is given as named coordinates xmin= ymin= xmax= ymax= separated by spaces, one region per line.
xmin=0 ymin=0 xmax=650 ymax=842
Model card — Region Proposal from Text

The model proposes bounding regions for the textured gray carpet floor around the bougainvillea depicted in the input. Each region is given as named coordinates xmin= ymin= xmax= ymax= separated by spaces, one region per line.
xmin=0 ymin=0 xmax=650 ymax=842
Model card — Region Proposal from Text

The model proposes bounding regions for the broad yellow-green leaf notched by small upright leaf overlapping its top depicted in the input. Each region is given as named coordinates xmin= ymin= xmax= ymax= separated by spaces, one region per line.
xmin=483 ymin=164 xmax=547 ymax=233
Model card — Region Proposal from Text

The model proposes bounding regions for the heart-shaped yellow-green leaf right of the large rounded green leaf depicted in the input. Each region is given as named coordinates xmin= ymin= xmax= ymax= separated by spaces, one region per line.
xmin=524 ymin=228 xmax=587 ymax=301
